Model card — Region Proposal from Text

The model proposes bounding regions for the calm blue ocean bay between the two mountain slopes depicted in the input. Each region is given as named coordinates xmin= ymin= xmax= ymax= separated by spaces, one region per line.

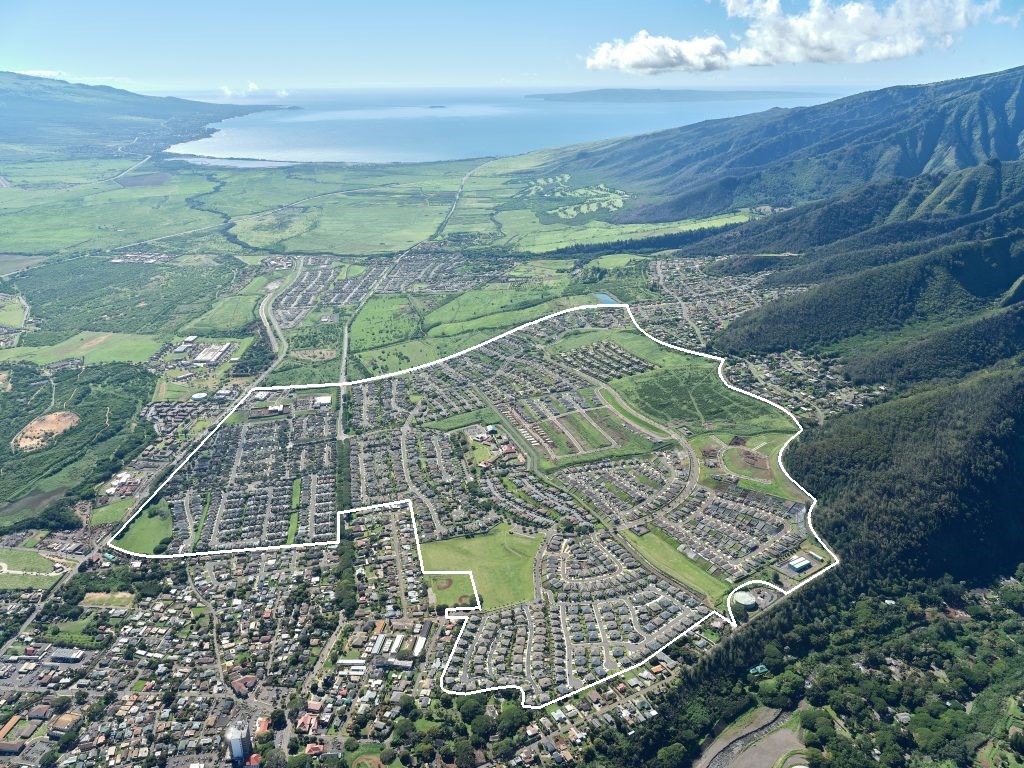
xmin=171 ymin=90 xmax=840 ymax=163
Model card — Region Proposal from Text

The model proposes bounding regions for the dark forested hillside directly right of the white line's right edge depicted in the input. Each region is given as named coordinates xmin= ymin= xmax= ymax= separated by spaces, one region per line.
xmin=786 ymin=369 xmax=1024 ymax=578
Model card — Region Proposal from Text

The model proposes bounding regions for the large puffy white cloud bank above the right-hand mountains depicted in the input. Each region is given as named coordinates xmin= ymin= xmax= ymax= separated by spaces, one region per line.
xmin=587 ymin=0 xmax=1005 ymax=74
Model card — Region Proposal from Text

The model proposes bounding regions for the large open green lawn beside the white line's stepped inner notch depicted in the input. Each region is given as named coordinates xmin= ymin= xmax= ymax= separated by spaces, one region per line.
xmin=421 ymin=523 xmax=542 ymax=610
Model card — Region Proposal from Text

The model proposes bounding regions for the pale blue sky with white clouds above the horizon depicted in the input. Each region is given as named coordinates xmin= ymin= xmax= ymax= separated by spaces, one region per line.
xmin=0 ymin=0 xmax=1024 ymax=100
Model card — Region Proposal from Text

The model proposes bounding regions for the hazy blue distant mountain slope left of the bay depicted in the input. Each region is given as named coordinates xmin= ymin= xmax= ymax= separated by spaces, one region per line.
xmin=0 ymin=72 xmax=267 ymax=161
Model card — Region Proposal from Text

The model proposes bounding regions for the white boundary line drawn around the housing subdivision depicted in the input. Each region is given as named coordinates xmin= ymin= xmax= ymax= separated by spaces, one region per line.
xmin=106 ymin=303 xmax=840 ymax=710
